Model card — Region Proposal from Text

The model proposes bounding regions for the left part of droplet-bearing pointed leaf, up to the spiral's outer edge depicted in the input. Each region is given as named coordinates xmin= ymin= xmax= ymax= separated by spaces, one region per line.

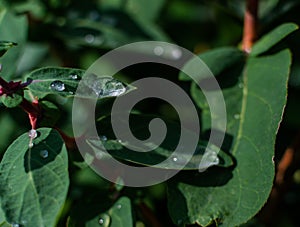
xmin=26 ymin=67 xmax=85 ymax=98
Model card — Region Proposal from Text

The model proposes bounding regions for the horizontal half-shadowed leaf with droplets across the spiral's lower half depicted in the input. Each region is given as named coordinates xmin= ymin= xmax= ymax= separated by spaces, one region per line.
xmin=90 ymin=114 xmax=233 ymax=170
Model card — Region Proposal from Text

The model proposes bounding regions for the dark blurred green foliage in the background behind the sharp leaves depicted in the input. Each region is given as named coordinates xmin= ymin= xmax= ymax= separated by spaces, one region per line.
xmin=0 ymin=0 xmax=300 ymax=226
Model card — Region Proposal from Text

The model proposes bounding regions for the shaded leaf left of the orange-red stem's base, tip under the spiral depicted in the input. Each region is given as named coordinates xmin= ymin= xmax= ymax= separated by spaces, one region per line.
xmin=179 ymin=47 xmax=245 ymax=81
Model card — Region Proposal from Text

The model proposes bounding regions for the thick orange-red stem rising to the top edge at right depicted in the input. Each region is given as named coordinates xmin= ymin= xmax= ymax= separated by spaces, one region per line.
xmin=242 ymin=0 xmax=259 ymax=53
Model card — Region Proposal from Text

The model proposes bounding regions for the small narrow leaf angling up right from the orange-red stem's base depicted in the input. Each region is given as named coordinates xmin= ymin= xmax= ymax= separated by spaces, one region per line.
xmin=250 ymin=23 xmax=298 ymax=56
